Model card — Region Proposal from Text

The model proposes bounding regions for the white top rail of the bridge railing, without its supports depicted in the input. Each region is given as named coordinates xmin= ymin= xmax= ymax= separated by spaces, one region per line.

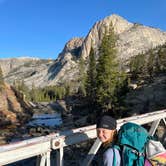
xmin=0 ymin=109 xmax=166 ymax=165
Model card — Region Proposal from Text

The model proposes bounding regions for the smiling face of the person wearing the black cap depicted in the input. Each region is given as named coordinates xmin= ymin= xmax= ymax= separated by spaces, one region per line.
xmin=97 ymin=128 xmax=114 ymax=143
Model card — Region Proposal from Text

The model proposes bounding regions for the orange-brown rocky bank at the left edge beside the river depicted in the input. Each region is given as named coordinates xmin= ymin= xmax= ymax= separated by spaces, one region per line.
xmin=0 ymin=84 xmax=31 ymax=127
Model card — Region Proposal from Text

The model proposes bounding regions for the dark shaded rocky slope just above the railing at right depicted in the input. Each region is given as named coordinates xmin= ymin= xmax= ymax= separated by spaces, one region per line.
xmin=125 ymin=74 xmax=166 ymax=116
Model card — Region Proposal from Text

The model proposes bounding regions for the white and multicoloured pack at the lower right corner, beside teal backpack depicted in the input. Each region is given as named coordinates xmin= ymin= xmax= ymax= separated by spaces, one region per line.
xmin=145 ymin=140 xmax=166 ymax=166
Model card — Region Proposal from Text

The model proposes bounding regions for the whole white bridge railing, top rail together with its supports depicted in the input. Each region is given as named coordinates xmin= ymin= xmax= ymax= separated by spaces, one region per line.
xmin=0 ymin=110 xmax=166 ymax=166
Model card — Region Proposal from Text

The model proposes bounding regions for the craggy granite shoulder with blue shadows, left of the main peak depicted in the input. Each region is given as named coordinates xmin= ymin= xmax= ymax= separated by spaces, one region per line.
xmin=46 ymin=38 xmax=84 ymax=85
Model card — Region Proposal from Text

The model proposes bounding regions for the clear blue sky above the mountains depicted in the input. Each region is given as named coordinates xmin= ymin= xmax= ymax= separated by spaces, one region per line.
xmin=0 ymin=0 xmax=166 ymax=59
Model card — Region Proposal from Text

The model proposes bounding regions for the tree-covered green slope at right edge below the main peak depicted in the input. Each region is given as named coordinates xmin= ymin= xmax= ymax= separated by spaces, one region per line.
xmin=129 ymin=44 xmax=166 ymax=80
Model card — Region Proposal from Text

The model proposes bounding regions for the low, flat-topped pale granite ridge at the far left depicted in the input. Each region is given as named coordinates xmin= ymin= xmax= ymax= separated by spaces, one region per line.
xmin=0 ymin=57 xmax=55 ymax=87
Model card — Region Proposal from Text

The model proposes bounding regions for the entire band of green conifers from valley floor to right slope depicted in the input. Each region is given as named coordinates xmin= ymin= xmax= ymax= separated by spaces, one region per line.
xmin=10 ymin=29 xmax=166 ymax=118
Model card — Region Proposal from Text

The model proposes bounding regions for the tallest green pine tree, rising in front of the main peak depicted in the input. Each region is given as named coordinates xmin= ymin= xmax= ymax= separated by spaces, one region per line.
xmin=96 ymin=24 xmax=125 ymax=111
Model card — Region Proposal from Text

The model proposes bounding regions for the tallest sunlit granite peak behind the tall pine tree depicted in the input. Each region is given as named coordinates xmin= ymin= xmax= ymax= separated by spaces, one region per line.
xmin=81 ymin=15 xmax=166 ymax=60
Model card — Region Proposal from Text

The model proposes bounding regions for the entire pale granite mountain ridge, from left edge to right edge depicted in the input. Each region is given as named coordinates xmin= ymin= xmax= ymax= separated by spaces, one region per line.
xmin=0 ymin=14 xmax=166 ymax=87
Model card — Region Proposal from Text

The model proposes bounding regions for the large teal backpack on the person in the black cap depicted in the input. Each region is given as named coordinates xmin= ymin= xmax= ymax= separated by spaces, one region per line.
xmin=118 ymin=122 xmax=149 ymax=166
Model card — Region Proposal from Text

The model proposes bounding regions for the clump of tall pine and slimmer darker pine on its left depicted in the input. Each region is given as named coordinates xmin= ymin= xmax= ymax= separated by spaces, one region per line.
xmin=86 ymin=25 xmax=128 ymax=114
